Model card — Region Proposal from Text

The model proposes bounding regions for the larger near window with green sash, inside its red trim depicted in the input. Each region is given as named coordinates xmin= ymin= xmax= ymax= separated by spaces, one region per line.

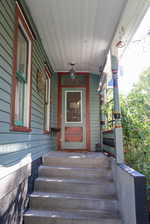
xmin=15 ymin=27 xmax=29 ymax=127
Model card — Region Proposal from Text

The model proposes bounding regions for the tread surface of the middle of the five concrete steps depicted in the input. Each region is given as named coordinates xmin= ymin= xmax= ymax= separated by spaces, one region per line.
xmin=36 ymin=177 xmax=113 ymax=185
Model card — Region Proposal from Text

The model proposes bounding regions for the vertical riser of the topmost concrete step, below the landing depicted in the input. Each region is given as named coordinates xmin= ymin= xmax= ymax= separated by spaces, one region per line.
xmin=43 ymin=157 xmax=110 ymax=168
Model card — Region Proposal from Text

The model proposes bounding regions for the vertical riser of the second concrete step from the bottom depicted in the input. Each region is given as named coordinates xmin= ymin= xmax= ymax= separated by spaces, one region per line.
xmin=30 ymin=197 xmax=118 ymax=214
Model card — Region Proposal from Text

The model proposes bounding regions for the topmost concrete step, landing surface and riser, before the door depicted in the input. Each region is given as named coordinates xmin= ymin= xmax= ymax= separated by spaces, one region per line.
xmin=43 ymin=152 xmax=110 ymax=168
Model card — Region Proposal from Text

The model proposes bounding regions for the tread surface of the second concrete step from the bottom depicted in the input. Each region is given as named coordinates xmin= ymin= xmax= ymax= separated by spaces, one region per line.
xmin=30 ymin=191 xmax=117 ymax=202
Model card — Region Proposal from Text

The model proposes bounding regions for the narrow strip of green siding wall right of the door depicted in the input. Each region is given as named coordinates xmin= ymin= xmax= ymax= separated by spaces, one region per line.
xmin=90 ymin=74 xmax=100 ymax=151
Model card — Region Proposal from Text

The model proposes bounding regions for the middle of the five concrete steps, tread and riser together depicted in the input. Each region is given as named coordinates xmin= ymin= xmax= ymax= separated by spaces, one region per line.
xmin=35 ymin=177 xmax=115 ymax=197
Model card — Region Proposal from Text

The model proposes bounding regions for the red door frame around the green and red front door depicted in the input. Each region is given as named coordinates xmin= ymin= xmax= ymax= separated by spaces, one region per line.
xmin=57 ymin=72 xmax=91 ymax=152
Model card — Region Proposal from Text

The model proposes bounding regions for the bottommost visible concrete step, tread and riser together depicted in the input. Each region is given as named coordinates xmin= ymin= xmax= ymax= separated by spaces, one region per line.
xmin=24 ymin=210 xmax=122 ymax=224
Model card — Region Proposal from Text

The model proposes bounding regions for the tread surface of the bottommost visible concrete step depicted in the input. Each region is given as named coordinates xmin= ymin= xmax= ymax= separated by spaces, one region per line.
xmin=24 ymin=209 xmax=120 ymax=221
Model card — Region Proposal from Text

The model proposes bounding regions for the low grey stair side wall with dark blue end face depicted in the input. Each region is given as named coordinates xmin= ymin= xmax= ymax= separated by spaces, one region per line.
xmin=112 ymin=159 xmax=148 ymax=224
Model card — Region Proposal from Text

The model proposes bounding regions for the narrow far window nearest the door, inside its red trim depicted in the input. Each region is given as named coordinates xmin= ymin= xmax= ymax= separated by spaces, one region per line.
xmin=44 ymin=68 xmax=51 ymax=133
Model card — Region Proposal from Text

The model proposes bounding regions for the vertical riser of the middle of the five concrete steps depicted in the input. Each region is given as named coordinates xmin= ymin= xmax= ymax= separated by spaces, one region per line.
xmin=35 ymin=181 xmax=115 ymax=196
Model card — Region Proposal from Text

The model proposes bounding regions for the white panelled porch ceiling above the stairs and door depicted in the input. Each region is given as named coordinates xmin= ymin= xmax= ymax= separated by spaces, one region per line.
xmin=26 ymin=0 xmax=126 ymax=73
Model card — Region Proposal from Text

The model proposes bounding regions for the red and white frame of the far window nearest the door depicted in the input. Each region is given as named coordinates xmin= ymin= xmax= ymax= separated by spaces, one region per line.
xmin=43 ymin=66 xmax=52 ymax=134
